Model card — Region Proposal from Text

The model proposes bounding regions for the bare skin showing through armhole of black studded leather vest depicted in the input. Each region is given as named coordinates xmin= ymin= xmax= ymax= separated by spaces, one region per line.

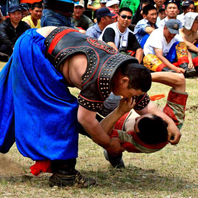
xmin=60 ymin=54 xmax=87 ymax=89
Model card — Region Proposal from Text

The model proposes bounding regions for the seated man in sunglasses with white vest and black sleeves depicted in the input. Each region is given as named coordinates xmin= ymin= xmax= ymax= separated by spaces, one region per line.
xmin=99 ymin=7 xmax=143 ymax=63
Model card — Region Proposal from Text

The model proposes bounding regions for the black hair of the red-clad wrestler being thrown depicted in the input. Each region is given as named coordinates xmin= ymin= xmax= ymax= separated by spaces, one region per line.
xmin=137 ymin=115 xmax=168 ymax=144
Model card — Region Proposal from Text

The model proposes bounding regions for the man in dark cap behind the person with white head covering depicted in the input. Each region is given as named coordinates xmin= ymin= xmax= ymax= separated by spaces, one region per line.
xmin=177 ymin=0 xmax=195 ymax=26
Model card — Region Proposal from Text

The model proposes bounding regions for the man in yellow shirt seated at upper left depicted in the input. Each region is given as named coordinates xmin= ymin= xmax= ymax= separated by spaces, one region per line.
xmin=22 ymin=3 xmax=43 ymax=28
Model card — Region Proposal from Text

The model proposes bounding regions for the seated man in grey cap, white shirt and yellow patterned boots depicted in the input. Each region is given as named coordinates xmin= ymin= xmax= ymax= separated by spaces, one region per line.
xmin=143 ymin=19 xmax=196 ymax=77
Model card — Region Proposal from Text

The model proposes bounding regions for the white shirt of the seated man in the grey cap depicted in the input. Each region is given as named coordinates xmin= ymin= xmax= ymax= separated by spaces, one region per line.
xmin=144 ymin=28 xmax=183 ymax=57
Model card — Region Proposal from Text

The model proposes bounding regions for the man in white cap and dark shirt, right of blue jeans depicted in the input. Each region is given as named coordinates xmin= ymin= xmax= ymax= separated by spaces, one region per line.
xmin=72 ymin=3 xmax=93 ymax=30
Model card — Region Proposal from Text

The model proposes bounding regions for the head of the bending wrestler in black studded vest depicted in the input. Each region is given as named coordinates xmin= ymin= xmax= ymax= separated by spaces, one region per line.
xmin=112 ymin=62 xmax=151 ymax=98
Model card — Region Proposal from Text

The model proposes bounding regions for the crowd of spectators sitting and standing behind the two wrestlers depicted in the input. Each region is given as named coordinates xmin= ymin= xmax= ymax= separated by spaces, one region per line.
xmin=0 ymin=0 xmax=198 ymax=77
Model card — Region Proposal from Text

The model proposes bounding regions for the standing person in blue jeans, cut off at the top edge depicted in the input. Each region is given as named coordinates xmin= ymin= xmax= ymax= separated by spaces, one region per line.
xmin=41 ymin=0 xmax=79 ymax=27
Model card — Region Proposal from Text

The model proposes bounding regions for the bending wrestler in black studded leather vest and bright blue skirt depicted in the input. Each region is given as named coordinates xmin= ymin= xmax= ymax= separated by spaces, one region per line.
xmin=0 ymin=27 xmax=181 ymax=187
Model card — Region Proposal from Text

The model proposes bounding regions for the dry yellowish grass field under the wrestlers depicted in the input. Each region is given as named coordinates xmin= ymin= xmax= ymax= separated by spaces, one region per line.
xmin=0 ymin=63 xmax=198 ymax=198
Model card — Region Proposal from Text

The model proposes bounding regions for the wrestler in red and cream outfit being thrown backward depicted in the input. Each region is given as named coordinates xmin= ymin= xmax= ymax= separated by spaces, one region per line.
xmin=101 ymin=72 xmax=188 ymax=168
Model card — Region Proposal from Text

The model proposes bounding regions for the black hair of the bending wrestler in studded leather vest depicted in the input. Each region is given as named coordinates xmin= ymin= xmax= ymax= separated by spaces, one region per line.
xmin=120 ymin=61 xmax=152 ymax=92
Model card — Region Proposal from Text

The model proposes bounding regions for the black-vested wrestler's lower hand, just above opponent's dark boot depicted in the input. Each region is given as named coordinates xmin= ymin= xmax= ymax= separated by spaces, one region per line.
xmin=105 ymin=138 xmax=124 ymax=156
